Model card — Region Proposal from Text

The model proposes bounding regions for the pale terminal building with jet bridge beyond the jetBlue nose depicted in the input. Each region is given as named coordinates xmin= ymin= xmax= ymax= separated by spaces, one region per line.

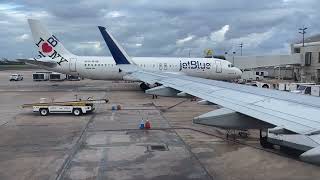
xmin=226 ymin=34 xmax=320 ymax=83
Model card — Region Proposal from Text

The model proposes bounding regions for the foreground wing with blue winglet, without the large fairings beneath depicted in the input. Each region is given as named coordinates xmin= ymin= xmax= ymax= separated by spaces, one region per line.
xmin=99 ymin=27 xmax=320 ymax=135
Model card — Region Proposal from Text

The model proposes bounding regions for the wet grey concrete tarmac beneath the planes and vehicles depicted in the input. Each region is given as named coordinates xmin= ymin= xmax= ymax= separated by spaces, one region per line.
xmin=0 ymin=70 xmax=320 ymax=180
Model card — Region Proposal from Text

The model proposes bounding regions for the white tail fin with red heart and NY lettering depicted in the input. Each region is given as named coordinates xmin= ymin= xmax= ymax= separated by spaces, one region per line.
xmin=28 ymin=19 xmax=74 ymax=62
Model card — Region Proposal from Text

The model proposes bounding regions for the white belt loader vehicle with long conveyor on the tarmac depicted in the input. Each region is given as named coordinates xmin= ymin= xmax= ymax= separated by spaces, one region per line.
xmin=22 ymin=99 xmax=109 ymax=116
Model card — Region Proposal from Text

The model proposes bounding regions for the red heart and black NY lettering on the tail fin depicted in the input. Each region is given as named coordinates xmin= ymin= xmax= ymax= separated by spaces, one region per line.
xmin=36 ymin=35 xmax=68 ymax=66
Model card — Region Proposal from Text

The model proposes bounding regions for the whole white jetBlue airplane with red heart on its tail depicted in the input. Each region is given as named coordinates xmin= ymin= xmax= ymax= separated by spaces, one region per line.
xmin=20 ymin=19 xmax=242 ymax=89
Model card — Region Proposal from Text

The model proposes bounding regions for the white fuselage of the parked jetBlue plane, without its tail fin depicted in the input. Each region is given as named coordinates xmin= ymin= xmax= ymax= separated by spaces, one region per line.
xmin=44 ymin=56 xmax=241 ymax=80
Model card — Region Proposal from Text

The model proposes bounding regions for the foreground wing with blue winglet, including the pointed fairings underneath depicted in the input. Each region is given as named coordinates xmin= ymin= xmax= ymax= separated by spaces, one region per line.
xmin=99 ymin=26 xmax=320 ymax=164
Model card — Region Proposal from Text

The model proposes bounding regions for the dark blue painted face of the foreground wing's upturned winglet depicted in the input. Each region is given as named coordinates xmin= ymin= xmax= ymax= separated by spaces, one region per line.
xmin=98 ymin=26 xmax=130 ymax=64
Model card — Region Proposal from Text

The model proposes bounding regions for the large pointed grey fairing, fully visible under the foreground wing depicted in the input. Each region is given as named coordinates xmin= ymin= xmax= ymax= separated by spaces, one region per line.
xmin=193 ymin=108 xmax=274 ymax=130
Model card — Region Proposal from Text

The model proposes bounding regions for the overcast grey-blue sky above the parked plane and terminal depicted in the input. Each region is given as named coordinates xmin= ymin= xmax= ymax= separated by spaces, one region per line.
xmin=0 ymin=0 xmax=320 ymax=58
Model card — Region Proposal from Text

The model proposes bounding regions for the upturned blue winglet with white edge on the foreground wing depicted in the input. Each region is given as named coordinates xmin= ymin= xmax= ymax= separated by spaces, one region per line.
xmin=98 ymin=26 xmax=134 ymax=64
